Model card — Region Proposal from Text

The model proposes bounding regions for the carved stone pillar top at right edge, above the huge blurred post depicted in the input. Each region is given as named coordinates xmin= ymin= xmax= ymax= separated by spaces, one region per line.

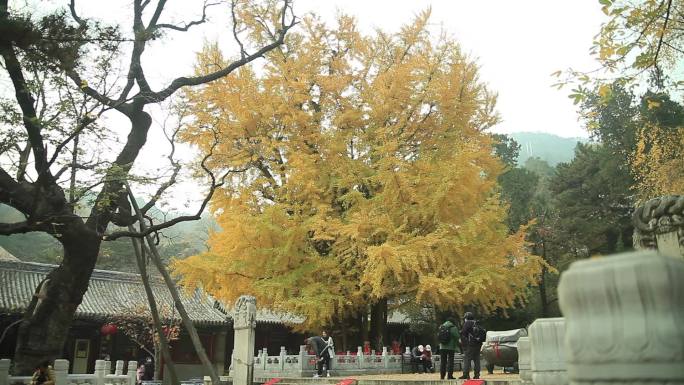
xmin=632 ymin=195 xmax=684 ymax=258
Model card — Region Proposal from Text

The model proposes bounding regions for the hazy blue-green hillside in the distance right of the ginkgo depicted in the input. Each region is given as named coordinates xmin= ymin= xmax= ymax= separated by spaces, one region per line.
xmin=509 ymin=132 xmax=587 ymax=166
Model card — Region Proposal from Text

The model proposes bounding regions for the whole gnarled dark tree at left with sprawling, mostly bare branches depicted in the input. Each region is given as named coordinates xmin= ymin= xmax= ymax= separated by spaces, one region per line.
xmin=0 ymin=0 xmax=296 ymax=373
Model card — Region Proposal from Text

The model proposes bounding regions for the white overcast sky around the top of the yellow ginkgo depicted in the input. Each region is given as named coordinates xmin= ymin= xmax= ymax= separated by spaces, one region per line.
xmin=131 ymin=0 xmax=604 ymax=137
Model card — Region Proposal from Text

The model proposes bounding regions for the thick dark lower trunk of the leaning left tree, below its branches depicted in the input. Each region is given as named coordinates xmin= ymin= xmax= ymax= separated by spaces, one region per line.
xmin=14 ymin=223 xmax=101 ymax=375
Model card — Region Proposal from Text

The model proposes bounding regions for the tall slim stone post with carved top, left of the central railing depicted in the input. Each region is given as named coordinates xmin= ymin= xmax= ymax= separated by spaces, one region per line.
xmin=234 ymin=295 xmax=256 ymax=385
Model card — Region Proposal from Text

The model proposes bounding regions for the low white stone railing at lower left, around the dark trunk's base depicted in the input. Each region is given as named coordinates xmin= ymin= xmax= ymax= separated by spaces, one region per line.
xmin=0 ymin=359 xmax=137 ymax=385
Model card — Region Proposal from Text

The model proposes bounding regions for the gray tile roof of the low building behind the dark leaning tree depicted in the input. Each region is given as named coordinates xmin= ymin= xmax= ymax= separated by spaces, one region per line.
xmin=0 ymin=260 xmax=229 ymax=326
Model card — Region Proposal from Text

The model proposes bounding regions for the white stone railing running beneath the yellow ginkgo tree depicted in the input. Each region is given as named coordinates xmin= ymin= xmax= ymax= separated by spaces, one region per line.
xmin=230 ymin=345 xmax=454 ymax=378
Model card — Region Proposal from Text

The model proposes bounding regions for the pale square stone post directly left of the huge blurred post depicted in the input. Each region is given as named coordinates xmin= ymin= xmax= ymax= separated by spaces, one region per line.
xmin=529 ymin=318 xmax=568 ymax=385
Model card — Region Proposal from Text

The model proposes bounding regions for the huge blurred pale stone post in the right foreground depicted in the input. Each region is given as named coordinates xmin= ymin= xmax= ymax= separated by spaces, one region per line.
xmin=558 ymin=250 xmax=684 ymax=385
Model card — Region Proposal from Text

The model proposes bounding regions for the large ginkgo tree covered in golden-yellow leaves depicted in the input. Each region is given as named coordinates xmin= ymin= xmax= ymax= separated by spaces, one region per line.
xmin=174 ymin=11 xmax=540 ymax=344
